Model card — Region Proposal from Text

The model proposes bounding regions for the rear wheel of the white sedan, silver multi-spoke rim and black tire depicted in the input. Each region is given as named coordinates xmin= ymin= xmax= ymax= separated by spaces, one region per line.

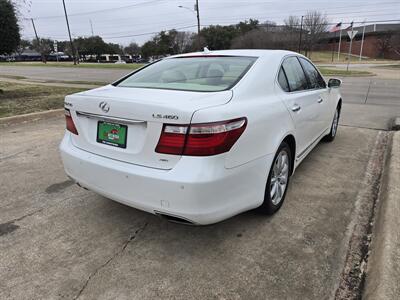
xmin=258 ymin=142 xmax=292 ymax=215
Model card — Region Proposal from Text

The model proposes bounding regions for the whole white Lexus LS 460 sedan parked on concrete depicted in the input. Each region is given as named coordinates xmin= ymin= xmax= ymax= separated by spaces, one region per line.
xmin=60 ymin=50 xmax=342 ymax=224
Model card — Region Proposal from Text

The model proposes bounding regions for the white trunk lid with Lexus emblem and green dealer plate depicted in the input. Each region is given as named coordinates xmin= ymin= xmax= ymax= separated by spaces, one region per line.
xmin=65 ymin=85 xmax=232 ymax=170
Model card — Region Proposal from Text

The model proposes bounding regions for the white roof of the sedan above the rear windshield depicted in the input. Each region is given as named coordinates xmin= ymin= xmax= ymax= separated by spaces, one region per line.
xmin=168 ymin=48 xmax=299 ymax=58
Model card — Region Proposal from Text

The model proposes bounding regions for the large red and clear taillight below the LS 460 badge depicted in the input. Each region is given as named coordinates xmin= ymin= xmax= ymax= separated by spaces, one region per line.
xmin=156 ymin=118 xmax=247 ymax=156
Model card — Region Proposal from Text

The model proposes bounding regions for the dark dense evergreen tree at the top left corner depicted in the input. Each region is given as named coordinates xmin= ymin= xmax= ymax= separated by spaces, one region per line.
xmin=0 ymin=0 xmax=21 ymax=54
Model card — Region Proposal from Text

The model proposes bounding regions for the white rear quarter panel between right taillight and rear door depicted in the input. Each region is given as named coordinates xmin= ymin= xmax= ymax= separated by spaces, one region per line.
xmin=192 ymin=95 xmax=293 ymax=168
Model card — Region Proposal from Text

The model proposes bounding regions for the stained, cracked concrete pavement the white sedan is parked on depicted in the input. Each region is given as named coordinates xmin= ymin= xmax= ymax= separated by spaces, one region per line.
xmin=0 ymin=116 xmax=380 ymax=299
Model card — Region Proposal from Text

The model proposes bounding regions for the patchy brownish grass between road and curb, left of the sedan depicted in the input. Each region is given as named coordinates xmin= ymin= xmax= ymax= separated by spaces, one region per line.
xmin=0 ymin=82 xmax=83 ymax=118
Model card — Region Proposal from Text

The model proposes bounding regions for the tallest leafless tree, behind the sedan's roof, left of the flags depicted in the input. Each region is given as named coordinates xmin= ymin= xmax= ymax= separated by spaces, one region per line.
xmin=303 ymin=10 xmax=328 ymax=55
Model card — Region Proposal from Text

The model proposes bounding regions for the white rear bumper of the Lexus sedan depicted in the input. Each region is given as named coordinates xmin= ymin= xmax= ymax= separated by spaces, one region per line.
xmin=60 ymin=132 xmax=273 ymax=224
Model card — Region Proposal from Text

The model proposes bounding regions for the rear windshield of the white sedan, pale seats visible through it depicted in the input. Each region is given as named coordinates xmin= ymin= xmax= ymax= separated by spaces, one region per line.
xmin=117 ymin=56 xmax=257 ymax=92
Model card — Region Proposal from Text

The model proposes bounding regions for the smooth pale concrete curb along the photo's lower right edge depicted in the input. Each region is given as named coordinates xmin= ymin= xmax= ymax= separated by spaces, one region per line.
xmin=363 ymin=132 xmax=400 ymax=299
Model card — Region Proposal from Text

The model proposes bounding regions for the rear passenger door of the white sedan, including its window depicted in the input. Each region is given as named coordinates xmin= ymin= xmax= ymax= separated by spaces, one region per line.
xmin=278 ymin=56 xmax=319 ymax=156
